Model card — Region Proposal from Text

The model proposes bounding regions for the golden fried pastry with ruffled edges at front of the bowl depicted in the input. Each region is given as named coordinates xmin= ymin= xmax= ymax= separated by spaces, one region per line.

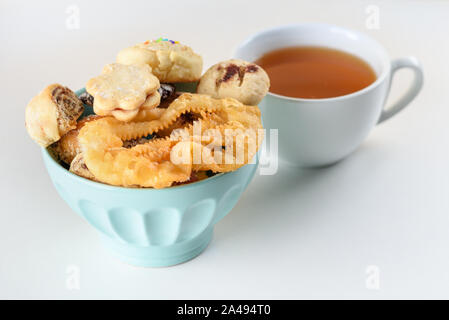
xmin=78 ymin=94 xmax=262 ymax=188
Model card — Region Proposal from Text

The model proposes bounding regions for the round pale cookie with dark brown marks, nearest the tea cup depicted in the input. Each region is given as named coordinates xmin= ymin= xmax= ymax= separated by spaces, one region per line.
xmin=197 ymin=59 xmax=270 ymax=105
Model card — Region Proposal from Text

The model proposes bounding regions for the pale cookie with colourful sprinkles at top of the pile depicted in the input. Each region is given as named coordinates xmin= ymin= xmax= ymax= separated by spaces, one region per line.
xmin=117 ymin=38 xmax=203 ymax=82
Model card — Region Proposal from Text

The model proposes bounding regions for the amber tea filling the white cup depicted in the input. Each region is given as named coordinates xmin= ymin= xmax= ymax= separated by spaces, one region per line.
xmin=255 ymin=47 xmax=376 ymax=99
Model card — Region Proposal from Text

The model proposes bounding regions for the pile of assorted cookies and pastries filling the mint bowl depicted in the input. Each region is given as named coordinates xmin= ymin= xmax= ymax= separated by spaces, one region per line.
xmin=25 ymin=38 xmax=270 ymax=188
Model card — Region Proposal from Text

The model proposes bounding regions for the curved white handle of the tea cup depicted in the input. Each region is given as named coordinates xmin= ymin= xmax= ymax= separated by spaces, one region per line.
xmin=378 ymin=57 xmax=424 ymax=124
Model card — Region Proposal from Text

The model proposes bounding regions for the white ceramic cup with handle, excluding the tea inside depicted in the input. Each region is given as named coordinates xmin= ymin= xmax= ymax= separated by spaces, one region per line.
xmin=234 ymin=23 xmax=423 ymax=167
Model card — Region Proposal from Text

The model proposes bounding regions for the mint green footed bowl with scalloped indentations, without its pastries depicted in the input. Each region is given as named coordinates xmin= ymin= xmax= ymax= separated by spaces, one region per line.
xmin=42 ymin=91 xmax=258 ymax=267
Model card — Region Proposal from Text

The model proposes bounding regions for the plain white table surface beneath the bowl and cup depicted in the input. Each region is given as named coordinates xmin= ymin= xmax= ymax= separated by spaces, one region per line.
xmin=0 ymin=0 xmax=449 ymax=299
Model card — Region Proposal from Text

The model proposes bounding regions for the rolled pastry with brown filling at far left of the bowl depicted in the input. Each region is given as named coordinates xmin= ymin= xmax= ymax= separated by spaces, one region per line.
xmin=25 ymin=84 xmax=84 ymax=147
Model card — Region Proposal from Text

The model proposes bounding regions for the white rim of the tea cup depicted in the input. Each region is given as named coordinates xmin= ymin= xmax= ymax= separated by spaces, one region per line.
xmin=233 ymin=22 xmax=391 ymax=103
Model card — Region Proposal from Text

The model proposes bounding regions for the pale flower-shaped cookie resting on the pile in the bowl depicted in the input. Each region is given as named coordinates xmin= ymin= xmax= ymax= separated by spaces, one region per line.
xmin=86 ymin=63 xmax=160 ymax=121
